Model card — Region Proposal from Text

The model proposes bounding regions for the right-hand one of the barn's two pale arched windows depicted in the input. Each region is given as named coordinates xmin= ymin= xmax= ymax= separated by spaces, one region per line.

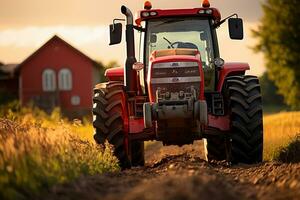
xmin=58 ymin=68 xmax=73 ymax=91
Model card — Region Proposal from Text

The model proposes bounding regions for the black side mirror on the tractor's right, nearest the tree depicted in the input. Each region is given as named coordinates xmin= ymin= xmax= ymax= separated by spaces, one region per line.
xmin=228 ymin=18 xmax=244 ymax=40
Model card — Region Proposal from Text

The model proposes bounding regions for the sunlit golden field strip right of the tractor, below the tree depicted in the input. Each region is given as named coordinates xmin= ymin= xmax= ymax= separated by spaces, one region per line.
xmin=264 ymin=112 xmax=300 ymax=160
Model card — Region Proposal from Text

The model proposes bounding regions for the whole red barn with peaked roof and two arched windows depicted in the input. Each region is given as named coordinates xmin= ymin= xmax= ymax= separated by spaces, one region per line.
xmin=19 ymin=36 xmax=100 ymax=117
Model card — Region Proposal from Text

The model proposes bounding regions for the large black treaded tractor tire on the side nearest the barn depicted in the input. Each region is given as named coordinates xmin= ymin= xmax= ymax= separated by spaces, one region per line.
xmin=93 ymin=82 xmax=131 ymax=169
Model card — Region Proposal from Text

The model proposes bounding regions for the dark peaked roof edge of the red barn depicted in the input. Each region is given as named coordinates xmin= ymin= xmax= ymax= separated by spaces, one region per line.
xmin=18 ymin=35 xmax=97 ymax=70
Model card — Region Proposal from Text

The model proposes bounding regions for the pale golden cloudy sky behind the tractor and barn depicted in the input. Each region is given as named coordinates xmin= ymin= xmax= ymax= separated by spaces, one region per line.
xmin=0 ymin=0 xmax=265 ymax=75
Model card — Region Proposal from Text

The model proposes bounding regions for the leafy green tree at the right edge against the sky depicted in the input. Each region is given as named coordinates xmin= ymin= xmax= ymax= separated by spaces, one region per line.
xmin=253 ymin=0 xmax=300 ymax=109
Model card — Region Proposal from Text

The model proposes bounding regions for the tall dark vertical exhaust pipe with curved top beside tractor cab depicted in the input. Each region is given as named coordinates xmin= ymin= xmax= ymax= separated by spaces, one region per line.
xmin=121 ymin=6 xmax=137 ymax=93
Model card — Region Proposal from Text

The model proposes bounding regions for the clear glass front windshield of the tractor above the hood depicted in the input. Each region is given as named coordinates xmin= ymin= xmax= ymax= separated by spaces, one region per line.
xmin=145 ymin=17 xmax=214 ymax=89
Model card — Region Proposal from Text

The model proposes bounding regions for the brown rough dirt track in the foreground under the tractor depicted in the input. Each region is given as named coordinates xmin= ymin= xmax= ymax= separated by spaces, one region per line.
xmin=43 ymin=142 xmax=300 ymax=200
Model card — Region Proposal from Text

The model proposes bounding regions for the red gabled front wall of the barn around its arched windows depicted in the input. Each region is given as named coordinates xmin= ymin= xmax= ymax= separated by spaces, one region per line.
xmin=21 ymin=40 xmax=93 ymax=117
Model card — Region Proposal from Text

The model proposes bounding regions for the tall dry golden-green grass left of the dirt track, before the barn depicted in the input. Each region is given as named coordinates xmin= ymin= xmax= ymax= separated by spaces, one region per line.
xmin=0 ymin=110 xmax=119 ymax=199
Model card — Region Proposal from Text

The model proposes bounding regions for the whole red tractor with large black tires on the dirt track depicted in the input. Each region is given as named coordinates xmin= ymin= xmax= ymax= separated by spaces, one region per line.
xmin=93 ymin=0 xmax=263 ymax=168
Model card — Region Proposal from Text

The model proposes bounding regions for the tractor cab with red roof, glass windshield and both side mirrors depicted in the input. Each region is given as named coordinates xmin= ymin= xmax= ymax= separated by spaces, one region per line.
xmin=110 ymin=1 xmax=243 ymax=95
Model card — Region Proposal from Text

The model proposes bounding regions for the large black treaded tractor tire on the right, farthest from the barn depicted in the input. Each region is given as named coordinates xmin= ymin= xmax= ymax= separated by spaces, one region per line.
xmin=224 ymin=76 xmax=263 ymax=164
